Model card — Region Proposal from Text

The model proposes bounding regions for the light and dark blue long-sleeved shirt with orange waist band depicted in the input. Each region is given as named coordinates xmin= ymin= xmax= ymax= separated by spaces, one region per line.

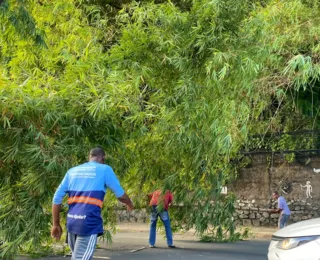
xmin=53 ymin=162 xmax=124 ymax=236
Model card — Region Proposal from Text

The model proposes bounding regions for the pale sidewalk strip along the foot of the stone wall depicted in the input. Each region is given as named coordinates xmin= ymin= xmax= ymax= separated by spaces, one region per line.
xmin=116 ymin=222 xmax=277 ymax=240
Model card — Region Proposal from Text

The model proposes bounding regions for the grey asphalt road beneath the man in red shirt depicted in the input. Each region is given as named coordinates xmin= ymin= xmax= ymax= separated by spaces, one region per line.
xmin=21 ymin=232 xmax=269 ymax=260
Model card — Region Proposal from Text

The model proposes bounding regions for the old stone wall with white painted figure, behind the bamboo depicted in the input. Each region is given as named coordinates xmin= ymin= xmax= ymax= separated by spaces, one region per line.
xmin=117 ymin=154 xmax=320 ymax=226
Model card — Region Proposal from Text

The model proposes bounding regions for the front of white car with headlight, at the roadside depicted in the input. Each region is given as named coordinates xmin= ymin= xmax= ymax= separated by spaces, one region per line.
xmin=268 ymin=218 xmax=320 ymax=260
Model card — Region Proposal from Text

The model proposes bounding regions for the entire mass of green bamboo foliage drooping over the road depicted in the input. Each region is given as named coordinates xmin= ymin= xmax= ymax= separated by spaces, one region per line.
xmin=0 ymin=0 xmax=320 ymax=256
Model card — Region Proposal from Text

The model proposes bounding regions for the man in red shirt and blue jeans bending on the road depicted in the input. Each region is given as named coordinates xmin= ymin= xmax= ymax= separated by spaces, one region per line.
xmin=148 ymin=190 xmax=175 ymax=248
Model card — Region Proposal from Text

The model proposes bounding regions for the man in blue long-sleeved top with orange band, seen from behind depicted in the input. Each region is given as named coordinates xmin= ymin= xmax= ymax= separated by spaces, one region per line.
xmin=51 ymin=148 xmax=133 ymax=260
